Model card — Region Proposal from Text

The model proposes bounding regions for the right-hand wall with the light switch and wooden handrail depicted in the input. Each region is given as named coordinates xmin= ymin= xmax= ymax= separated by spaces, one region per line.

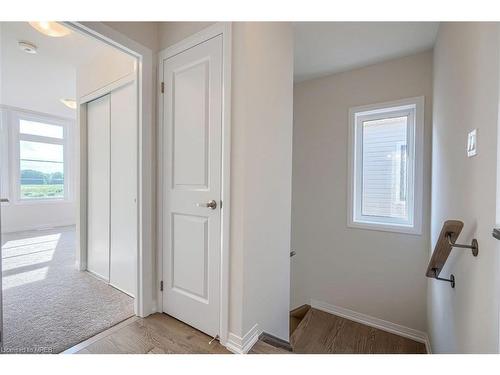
xmin=428 ymin=23 xmax=500 ymax=353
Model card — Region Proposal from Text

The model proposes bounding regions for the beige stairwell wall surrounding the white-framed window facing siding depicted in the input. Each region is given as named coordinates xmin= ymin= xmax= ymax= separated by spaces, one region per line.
xmin=292 ymin=51 xmax=432 ymax=331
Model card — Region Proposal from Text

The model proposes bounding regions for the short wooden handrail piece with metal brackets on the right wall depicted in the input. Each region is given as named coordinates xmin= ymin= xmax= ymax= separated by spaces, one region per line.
xmin=425 ymin=220 xmax=479 ymax=288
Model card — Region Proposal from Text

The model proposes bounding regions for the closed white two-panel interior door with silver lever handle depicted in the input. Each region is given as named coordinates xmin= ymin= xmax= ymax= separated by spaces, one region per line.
xmin=163 ymin=36 xmax=222 ymax=336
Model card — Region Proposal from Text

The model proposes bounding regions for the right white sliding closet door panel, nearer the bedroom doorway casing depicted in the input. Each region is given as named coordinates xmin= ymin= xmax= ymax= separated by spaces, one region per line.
xmin=110 ymin=82 xmax=138 ymax=296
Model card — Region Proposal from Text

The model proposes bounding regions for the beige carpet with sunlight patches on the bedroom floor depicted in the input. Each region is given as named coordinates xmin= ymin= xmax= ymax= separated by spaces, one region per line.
xmin=2 ymin=227 xmax=134 ymax=353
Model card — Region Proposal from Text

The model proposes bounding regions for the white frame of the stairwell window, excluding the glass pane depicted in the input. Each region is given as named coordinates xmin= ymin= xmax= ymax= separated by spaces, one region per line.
xmin=347 ymin=96 xmax=424 ymax=235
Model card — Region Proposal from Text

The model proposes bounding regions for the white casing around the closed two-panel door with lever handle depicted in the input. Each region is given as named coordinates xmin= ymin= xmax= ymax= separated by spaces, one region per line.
xmin=156 ymin=22 xmax=232 ymax=345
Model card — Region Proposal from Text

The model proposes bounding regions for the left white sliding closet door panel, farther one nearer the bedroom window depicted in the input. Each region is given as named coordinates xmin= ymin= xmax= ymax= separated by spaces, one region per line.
xmin=87 ymin=95 xmax=110 ymax=281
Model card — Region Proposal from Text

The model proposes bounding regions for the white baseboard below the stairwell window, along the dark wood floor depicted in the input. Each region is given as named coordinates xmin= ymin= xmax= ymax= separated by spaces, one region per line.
xmin=311 ymin=299 xmax=431 ymax=354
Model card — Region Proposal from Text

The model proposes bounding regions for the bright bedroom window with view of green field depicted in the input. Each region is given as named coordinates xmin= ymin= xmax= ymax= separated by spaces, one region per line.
xmin=13 ymin=113 xmax=69 ymax=202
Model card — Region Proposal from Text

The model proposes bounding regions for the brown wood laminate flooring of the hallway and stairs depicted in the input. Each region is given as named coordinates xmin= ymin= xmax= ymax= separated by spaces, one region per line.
xmin=65 ymin=309 xmax=425 ymax=354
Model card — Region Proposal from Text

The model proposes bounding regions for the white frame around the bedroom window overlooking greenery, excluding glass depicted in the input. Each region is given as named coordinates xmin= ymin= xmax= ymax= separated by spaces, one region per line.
xmin=9 ymin=110 xmax=73 ymax=205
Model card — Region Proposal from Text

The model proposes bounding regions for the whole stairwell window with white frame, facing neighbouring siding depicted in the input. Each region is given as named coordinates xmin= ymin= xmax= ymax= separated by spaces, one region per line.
xmin=348 ymin=98 xmax=423 ymax=233
